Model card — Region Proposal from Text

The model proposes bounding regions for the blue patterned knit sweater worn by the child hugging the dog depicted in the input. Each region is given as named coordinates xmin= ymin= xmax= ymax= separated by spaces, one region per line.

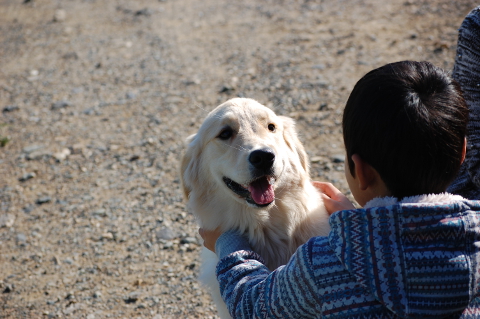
xmin=216 ymin=194 xmax=480 ymax=319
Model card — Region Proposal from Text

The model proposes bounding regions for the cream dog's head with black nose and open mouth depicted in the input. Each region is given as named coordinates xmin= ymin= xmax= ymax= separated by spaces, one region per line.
xmin=181 ymin=98 xmax=308 ymax=219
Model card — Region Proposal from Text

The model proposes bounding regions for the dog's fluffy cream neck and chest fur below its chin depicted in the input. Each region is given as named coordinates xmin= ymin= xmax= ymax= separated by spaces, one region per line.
xmin=189 ymin=181 xmax=325 ymax=268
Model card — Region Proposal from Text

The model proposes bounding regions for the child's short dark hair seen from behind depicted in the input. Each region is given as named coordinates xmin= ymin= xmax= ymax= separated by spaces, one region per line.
xmin=343 ymin=61 xmax=469 ymax=198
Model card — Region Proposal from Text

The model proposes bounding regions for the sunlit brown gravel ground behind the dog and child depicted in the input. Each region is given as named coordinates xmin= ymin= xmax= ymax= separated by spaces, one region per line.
xmin=0 ymin=0 xmax=476 ymax=319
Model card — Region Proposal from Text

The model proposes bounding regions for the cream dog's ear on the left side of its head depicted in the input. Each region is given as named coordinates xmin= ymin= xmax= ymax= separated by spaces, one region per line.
xmin=180 ymin=134 xmax=200 ymax=200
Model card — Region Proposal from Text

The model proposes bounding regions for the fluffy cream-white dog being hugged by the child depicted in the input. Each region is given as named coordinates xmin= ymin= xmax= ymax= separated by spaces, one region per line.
xmin=181 ymin=98 xmax=329 ymax=318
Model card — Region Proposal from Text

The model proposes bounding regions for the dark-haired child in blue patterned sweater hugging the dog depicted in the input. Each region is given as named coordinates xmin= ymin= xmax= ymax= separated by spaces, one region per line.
xmin=200 ymin=6 xmax=480 ymax=318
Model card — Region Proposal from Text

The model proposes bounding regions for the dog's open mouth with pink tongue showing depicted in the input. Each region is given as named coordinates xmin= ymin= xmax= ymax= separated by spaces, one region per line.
xmin=223 ymin=176 xmax=275 ymax=207
